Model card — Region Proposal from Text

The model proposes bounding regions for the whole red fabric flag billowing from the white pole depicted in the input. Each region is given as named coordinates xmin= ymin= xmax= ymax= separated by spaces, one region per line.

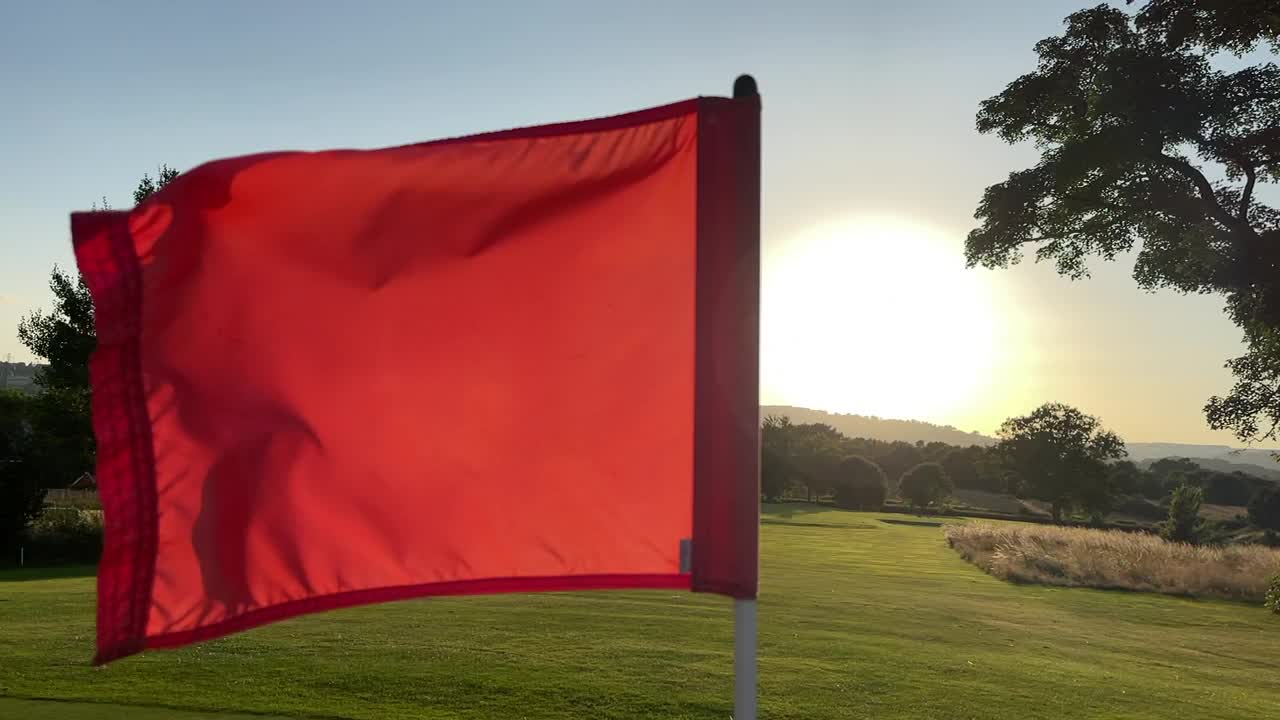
xmin=72 ymin=97 xmax=759 ymax=662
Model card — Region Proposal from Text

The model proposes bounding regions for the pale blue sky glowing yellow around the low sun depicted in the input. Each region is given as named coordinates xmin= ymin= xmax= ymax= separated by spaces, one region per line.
xmin=0 ymin=0 xmax=1259 ymax=445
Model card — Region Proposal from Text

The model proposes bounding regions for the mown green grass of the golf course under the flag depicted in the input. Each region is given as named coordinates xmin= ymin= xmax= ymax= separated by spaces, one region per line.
xmin=0 ymin=506 xmax=1280 ymax=720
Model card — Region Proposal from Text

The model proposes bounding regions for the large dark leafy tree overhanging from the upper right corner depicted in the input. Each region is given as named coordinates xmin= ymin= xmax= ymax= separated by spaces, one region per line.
xmin=965 ymin=0 xmax=1280 ymax=441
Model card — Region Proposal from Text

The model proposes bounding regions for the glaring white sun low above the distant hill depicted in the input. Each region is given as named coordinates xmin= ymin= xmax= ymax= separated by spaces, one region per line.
xmin=760 ymin=212 xmax=1001 ymax=423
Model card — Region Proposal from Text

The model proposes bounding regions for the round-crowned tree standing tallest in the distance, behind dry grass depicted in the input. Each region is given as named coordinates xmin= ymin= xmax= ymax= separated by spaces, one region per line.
xmin=996 ymin=402 xmax=1128 ymax=521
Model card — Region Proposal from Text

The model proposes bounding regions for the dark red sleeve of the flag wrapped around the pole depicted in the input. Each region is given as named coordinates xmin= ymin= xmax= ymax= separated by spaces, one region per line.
xmin=691 ymin=96 xmax=760 ymax=600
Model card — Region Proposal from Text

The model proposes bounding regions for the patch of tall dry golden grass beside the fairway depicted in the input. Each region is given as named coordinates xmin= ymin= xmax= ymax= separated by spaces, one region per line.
xmin=946 ymin=523 xmax=1280 ymax=602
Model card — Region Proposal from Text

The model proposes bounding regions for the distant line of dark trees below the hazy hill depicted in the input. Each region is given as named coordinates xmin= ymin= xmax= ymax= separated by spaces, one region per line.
xmin=760 ymin=404 xmax=1280 ymax=541
